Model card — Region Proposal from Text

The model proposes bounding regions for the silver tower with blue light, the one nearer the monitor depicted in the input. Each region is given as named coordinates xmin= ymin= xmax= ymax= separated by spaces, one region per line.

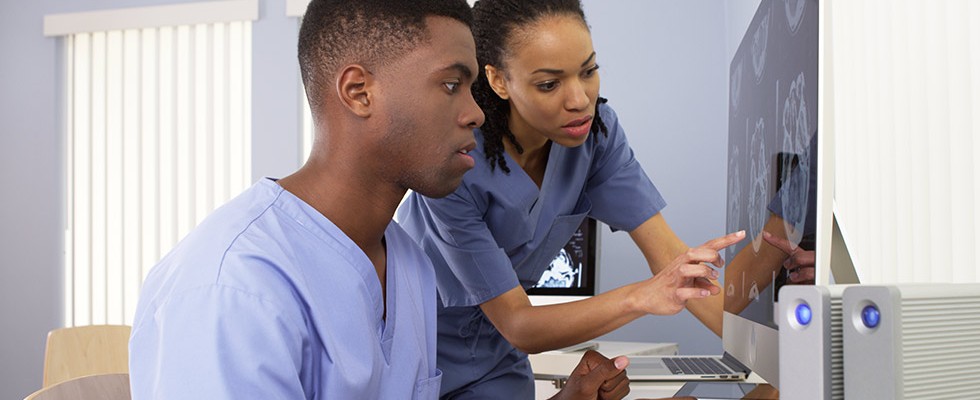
xmin=778 ymin=285 xmax=847 ymax=400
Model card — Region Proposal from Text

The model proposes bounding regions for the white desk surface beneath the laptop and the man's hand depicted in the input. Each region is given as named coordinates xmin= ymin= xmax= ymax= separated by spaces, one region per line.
xmin=528 ymin=341 xmax=765 ymax=400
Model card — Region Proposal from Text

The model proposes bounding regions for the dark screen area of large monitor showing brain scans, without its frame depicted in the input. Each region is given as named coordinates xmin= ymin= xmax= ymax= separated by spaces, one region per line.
xmin=725 ymin=0 xmax=818 ymax=327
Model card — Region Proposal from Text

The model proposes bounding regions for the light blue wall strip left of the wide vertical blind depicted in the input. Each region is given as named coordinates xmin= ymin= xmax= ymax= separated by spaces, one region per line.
xmin=0 ymin=1 xmax=64 ymax=399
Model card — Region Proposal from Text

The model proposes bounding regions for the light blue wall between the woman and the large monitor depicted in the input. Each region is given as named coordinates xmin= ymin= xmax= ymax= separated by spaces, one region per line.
xmin=583 ymin=0 xmax=760 ymax=354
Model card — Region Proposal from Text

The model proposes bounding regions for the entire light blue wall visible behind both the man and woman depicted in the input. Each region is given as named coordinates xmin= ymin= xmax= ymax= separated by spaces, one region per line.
xmin=0 ymin=0 xmax=758 ymax=399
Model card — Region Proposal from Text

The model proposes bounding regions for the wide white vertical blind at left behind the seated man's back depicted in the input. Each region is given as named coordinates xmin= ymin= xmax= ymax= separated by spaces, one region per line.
xmin=45 ymin=2 xmax=257 ymax=326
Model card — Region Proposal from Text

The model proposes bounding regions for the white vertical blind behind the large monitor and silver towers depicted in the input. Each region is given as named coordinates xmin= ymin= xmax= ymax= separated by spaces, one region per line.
xmin=832 ymin=0 xmax=980 ymax=283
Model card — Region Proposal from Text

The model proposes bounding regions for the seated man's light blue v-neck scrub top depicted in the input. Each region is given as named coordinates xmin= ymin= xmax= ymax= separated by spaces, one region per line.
xmin=129 ymin=179 xmax=441 ymax=399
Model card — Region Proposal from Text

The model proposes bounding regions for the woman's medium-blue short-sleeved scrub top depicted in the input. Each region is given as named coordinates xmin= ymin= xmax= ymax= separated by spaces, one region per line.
xmin=397 ymin=104 xmax=666 ymax=307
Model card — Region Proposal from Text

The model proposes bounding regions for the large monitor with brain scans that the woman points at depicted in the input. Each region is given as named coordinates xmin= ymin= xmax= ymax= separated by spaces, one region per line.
xmin=723 ymin=0 xmax=833 ymax=387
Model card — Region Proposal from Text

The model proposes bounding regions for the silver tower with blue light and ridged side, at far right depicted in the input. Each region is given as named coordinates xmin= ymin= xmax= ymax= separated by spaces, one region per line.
xmin=843 ymin=283 xmax=980 ymax=400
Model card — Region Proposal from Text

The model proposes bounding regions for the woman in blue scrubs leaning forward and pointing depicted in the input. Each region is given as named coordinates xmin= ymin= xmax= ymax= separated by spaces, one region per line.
xmin=399 ymin=0 xmax=744 ymax=399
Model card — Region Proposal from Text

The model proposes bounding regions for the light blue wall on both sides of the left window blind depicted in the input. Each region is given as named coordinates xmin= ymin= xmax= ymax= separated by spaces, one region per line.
xmin=0 ymin=0 xmax=301 ymax=399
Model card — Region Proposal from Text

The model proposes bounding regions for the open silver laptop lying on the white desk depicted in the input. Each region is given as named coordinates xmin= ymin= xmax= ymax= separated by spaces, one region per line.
xmin=626 ymin=353 xmax=751 ymax=381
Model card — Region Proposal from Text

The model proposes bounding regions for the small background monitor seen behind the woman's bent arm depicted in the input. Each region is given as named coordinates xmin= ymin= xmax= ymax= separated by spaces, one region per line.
xmin=527 ymin=218 xmax=599 ymax=305
